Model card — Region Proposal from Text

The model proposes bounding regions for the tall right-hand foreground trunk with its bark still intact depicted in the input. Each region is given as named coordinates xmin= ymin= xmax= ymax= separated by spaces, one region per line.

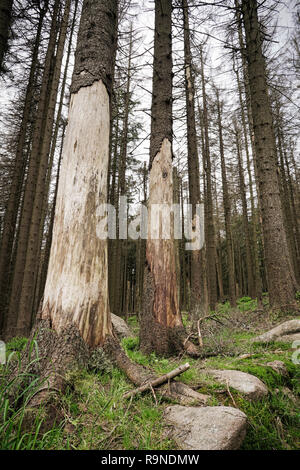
xmin=242 ymin=0 xmax=297 ymax=308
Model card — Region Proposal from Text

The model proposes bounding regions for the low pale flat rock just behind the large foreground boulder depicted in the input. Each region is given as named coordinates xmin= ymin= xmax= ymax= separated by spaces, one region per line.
xmin=205 ymin=369 xmax=268 ymax=400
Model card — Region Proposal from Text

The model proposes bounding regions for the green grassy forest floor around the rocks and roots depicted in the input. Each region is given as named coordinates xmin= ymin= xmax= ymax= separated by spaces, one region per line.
xmin=0 ymin=298 xmax=300 ymax=450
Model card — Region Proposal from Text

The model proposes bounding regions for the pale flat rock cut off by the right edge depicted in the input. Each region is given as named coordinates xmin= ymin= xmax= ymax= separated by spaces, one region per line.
xmin=252 ymin=318 xmax=300 ymax=343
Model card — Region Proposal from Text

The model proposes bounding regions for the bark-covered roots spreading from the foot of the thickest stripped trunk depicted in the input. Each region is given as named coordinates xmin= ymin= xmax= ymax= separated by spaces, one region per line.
xmin=10 ymin=320 xmax=208 ymax=429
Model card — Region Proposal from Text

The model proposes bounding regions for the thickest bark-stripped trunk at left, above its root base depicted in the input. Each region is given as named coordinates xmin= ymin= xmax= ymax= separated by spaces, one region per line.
xmin=42 ymin=0 xmax=117 ymax=347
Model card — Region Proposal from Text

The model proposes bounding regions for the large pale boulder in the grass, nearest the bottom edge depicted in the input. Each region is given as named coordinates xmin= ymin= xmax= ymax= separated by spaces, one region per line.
xmin=164 ymin=405 xmax=247 ymax=450
